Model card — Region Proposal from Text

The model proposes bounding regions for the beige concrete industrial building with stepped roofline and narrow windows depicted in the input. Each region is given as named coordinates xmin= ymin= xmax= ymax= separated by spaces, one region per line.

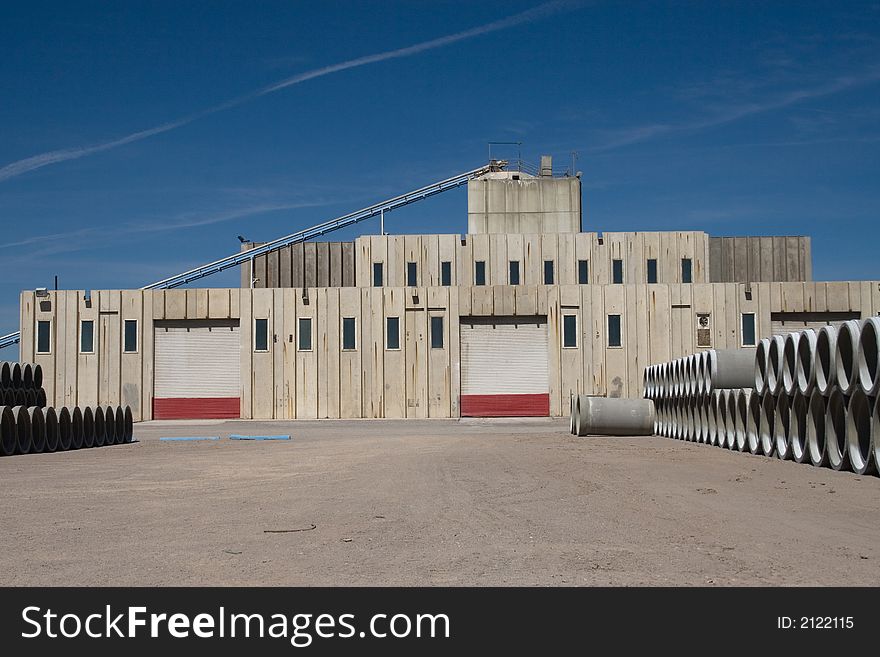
xmin=21 ymin=156 xmax=868 ymax=419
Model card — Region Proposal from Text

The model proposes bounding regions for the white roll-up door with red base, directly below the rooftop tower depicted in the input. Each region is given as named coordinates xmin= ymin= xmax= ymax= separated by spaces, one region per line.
xmin=461 ymin=317 xmax=550 ymax=417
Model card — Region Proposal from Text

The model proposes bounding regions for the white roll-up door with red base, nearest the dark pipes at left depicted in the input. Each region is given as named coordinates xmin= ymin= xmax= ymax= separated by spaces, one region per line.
xmin=153 ymin=320 xmax=241 ymax=420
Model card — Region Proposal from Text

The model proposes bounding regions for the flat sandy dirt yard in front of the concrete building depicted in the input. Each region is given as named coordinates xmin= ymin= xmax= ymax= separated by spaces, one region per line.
xmin=0 ymin=420 xmax=880 ymax=586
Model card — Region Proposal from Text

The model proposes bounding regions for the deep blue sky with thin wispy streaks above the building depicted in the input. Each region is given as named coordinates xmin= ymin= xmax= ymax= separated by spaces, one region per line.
xmin=0 ymin=0 xmax=880 ymax=333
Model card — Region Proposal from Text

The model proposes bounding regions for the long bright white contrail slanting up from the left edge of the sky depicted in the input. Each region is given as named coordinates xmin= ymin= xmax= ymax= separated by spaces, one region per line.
xmin=0 ymin=0 xmax=582 ymax=182
